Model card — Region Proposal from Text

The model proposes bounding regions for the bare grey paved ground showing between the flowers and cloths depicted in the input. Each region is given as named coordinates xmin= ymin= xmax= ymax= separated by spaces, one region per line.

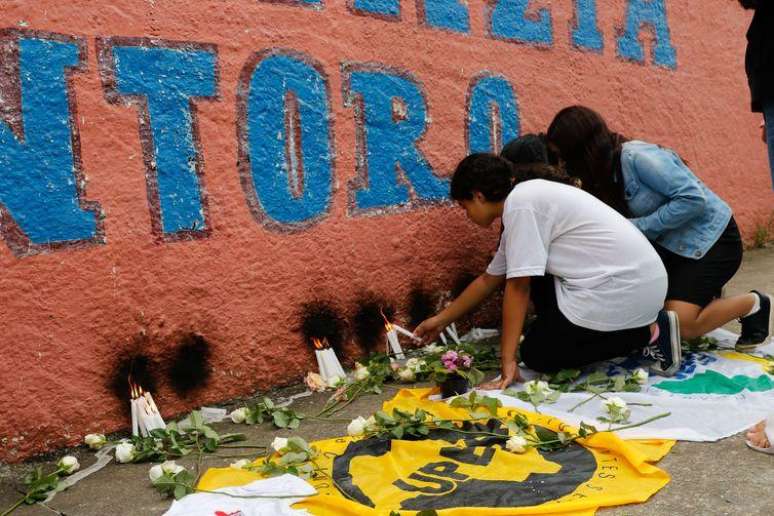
xmin=0 ymin=249 xmax=774 ymax=516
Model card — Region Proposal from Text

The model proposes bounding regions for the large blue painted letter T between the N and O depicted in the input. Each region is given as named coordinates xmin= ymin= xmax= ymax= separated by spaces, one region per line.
xmin=103 ymin=43 xmax=217 ymax=238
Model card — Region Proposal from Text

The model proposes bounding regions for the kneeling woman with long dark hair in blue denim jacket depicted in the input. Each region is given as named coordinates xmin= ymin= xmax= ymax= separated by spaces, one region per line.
xmin=547 ymin=106 xmax=772 ymax=351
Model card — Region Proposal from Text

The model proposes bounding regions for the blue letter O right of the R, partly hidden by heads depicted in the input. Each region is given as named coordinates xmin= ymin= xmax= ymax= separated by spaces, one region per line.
xmin=467 ymin=76 xmax=520 ymax=154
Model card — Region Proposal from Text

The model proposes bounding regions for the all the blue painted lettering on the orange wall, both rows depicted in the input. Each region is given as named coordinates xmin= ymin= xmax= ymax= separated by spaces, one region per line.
xmin=0 ymin=0 xmax=676 ymax=256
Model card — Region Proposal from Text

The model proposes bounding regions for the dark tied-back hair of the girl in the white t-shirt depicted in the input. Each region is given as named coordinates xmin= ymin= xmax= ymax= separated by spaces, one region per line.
xmin=450 ymin=153 xmax=572 ymax=202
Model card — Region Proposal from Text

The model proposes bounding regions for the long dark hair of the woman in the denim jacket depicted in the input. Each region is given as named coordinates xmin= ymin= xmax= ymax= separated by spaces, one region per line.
xmin=546 ymin=106 xmax=631 ymax=217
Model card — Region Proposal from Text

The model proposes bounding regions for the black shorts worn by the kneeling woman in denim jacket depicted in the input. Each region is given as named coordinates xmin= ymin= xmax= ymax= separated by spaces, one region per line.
xmin=654 ymin=217 xmax=742 ymax=308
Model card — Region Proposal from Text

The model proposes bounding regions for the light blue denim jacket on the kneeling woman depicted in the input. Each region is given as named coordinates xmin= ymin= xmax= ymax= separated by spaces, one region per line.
xmin=621 ymin=141 xmax=731 ymax=260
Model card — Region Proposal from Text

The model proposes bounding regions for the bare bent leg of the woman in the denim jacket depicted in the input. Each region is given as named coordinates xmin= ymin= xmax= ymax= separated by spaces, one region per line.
xmin=664 ymin=294 xmax=755 ymax=339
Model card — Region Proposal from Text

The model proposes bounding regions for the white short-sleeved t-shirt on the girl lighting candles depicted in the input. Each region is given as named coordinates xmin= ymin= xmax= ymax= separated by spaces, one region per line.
xmin=486 ymin=179 xmax=667 ymax=331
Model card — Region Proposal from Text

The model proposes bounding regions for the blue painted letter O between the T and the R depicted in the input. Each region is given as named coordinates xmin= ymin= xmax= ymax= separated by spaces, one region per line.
xmin=238 ymin=52 xmax=332 ymax=227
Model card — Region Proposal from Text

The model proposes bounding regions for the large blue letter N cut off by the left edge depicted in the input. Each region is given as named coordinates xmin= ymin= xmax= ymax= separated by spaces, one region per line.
xmin=0 ymin=35 xmax=99 ymax=254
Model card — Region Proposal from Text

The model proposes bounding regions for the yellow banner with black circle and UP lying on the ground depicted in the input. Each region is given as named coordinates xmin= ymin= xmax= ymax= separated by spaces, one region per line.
xmin=199 ymin=389 xmax=674 ymax=516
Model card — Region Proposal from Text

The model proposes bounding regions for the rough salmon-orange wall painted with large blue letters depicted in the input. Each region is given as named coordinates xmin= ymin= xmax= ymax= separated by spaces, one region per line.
xmin=0 ymin=0 xmax=774 ymax=460
